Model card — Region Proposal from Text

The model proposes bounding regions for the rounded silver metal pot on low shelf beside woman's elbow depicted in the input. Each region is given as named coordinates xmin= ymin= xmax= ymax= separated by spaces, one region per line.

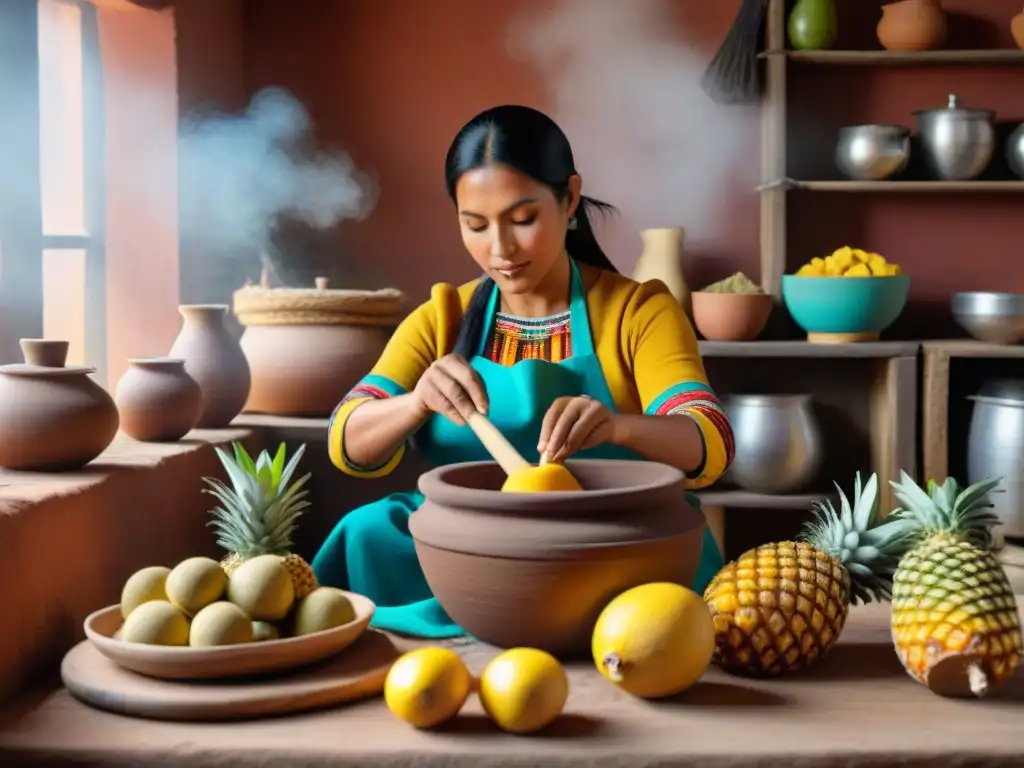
xmin=722 ymin=394 xmax=823 ymax=494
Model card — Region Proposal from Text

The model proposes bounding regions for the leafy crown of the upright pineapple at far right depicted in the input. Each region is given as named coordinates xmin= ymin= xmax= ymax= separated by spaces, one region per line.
xmin=890 ymin=472 xmax=1002 ymax=550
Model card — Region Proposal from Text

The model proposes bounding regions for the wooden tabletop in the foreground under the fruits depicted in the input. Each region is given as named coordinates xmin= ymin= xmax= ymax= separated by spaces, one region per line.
xmin=0 ymin=598 xmax=1024 ymax=768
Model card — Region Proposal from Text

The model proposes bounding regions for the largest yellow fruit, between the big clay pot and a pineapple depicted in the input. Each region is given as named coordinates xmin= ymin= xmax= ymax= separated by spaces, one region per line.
xmin=591 ymin=582 xmax=715 ymax=698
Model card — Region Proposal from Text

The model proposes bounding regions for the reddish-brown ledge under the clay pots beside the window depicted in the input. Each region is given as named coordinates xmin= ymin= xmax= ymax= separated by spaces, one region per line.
xmin=0 ymin=426 xmax=264 ymax=700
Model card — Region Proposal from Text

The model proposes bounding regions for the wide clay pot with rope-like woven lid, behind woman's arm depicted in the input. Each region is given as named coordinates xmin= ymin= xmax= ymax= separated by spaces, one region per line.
xmin=234 ymin=278 xmax=406 ymax=417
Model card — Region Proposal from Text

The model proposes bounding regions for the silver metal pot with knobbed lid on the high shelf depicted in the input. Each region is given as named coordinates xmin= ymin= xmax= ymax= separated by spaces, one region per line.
xmin=913 ymin=94 xmax=995 ymax=181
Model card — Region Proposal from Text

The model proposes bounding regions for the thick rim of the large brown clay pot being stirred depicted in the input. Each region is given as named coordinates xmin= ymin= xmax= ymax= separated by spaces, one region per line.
xmin=418 ymin=459 xmax=686 ymax=516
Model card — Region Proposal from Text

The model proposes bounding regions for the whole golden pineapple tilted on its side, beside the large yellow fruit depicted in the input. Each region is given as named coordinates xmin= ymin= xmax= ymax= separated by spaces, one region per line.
xmin=705 ymin=473 xmax=908 ymax=677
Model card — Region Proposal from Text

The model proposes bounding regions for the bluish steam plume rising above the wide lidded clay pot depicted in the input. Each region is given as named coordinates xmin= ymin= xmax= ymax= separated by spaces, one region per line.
xmin=178 ymin=88 xmax=377 ymax=256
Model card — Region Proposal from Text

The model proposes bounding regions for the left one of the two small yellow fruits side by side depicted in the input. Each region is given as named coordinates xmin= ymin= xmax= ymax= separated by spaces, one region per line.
xmin=384 ymin=647 xmax=473 ymax=728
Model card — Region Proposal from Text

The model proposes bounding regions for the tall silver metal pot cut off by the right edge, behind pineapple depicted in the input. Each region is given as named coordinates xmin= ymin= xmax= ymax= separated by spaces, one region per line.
xmin=966 ymin=379 xmax=1024 ymax=537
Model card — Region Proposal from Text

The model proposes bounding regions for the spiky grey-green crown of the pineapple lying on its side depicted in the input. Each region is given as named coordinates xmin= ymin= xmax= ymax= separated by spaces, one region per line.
xmin=800 ymin=472 xmax=913 ymax=603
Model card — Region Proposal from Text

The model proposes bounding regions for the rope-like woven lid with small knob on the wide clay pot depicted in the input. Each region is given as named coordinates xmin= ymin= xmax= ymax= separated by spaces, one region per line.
xmin=232 ymin=278 xmax=406 ymax=326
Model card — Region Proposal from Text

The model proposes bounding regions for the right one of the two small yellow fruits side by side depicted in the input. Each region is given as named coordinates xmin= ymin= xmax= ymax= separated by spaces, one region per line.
xmin=479 ymin=648 xmax=569 ymax=733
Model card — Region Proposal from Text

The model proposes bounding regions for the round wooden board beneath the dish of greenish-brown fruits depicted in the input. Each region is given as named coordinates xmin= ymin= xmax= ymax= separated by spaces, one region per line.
xmin=60 ymin=630 xmax=401 ymax=722
